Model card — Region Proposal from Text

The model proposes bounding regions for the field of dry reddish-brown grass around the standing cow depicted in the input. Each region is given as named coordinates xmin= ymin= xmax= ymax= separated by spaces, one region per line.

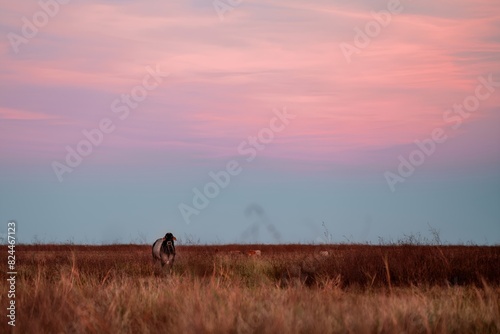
xmin=0 ymin=245 xmax=500 ymax=333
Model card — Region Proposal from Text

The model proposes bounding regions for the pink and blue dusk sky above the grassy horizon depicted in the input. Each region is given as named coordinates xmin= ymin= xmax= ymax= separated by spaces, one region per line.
xmin=0 ymin=0 xmax=500 ymax=245
